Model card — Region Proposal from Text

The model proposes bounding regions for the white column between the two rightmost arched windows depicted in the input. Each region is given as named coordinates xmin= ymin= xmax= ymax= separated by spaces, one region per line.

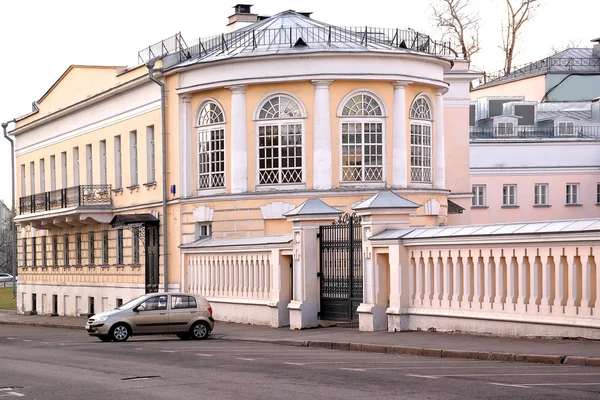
xmin=392 ymin=82 xmax=409 ymax=187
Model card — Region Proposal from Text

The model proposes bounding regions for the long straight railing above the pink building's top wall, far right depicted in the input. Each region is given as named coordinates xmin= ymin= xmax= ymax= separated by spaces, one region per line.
xmin=469 ymin=126 xmax=600 ymax=142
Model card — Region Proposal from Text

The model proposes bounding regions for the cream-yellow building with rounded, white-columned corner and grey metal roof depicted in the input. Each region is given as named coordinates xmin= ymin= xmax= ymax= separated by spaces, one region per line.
xmin=12 ymin=7 xmax=475 ymax=326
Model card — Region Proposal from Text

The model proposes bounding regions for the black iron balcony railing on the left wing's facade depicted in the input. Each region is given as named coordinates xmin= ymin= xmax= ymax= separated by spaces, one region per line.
xmin=19 ymin=185 xmax=112 ymax=214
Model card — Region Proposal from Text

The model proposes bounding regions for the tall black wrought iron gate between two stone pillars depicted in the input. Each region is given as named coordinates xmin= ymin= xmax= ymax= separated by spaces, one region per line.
xmin=319 ymin=214 xmax=363 ymax=321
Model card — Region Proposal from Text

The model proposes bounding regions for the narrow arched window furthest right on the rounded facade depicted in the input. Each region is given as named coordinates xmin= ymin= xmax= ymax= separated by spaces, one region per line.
xmin=410 ymin=96 xmax=432 ymax=183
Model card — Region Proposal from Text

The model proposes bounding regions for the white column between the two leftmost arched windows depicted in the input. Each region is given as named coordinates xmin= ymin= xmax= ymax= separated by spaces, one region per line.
xmin=228 ymin=86 xmax=248 ymax=193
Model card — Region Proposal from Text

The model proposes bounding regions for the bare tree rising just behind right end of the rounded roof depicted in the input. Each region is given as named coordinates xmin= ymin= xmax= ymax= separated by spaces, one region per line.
xmin=431 ymin=0 xmax=481 ymax=60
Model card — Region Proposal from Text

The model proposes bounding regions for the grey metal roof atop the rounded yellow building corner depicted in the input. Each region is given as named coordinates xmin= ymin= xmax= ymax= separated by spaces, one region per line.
xmin=169 ymin=10 xmax=455 ymax=68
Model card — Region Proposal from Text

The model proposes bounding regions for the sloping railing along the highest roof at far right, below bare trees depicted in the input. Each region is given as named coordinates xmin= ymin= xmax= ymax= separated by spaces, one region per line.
xmin=479 ymin=57 xmax=600 ymax=85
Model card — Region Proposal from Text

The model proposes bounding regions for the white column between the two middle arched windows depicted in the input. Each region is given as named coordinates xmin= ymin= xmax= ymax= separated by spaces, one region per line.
xmin=312 ymin=81 xmax=333 ymax=190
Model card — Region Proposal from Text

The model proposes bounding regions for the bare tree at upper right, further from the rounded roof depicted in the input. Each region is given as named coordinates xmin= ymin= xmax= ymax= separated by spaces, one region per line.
xmin=500 ymin=0 xmax=540 ymax=74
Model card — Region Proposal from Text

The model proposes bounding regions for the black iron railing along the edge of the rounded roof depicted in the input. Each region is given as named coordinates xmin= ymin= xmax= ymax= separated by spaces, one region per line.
xmin=138 ymin=25 xmax=457 ymax=63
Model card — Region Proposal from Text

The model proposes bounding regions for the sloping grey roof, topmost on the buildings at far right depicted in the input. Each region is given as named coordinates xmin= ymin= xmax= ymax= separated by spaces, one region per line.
xmin=473 ymin=48 xmax=600 ymax=91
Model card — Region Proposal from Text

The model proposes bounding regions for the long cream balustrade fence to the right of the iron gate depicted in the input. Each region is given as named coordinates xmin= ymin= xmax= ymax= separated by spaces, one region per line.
xmin=408 ymin=244 xmax=600 ymax=327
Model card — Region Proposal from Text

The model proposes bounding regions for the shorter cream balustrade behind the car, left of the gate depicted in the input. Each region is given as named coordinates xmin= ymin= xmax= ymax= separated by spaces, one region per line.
xmin=185 ymin=252 xmax=273 ymax=300
